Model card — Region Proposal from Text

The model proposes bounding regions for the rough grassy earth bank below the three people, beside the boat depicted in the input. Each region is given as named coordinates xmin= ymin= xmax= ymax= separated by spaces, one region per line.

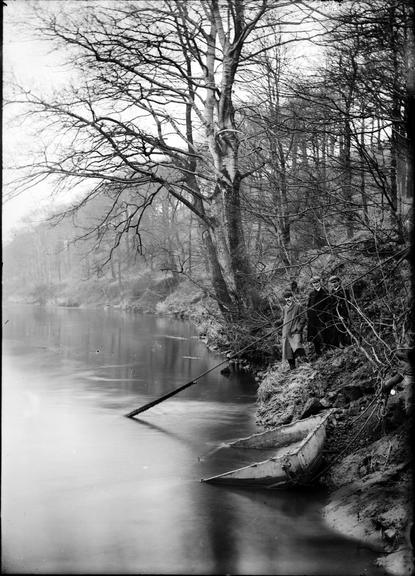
xmin=257 ymin=346 xmax=413 ymax=576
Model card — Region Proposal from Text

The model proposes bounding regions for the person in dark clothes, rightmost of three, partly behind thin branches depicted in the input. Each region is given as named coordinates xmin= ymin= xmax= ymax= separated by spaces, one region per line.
xmin=329 ymin=276 xmax=351 ymax=348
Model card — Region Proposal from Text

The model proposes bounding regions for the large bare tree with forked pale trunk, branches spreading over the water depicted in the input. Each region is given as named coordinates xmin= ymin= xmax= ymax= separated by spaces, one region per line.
xmin=8 ymin=0 xmax=306 ymax=316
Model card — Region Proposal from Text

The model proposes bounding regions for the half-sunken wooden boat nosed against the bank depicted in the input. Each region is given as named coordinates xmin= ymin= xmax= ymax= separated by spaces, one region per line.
xmin=202 ymin=410 xmax=333 ymax=488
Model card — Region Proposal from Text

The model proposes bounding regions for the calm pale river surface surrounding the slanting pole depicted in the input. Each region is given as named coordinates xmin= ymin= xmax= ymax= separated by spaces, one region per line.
xmin=2 ymin=306 xmax=383 ymax=575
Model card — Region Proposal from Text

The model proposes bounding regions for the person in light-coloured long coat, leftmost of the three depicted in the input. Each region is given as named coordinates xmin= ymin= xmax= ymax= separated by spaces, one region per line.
xmin=282 ymin=290 xmax=306 ymax=370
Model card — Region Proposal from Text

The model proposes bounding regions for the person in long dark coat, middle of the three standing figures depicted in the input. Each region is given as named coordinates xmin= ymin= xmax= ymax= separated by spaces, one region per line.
xmin=307 ymin=276 xmax=330 ymax=356
